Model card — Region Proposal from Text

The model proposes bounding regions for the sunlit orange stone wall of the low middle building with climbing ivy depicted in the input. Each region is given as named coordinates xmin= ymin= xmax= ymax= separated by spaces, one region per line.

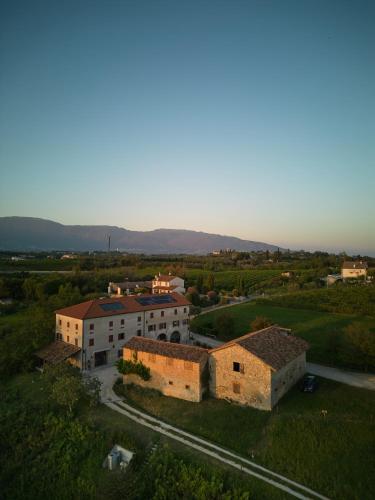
xmin=123 ymin=347 xmax=208 ymax=402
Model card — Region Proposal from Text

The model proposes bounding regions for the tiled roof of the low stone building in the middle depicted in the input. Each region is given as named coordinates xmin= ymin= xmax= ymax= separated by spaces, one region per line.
xmin=124 ymin=337 xmax=208 ymax=363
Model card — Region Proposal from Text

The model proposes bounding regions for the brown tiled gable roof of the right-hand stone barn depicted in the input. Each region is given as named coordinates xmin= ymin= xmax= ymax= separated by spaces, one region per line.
xmin=210 ymin=325 xmax=309 ymax=371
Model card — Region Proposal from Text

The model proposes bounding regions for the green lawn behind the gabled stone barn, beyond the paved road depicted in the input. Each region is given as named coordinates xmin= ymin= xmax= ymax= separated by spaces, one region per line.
xmin=191 ymin=302 xmax=374 ymax=366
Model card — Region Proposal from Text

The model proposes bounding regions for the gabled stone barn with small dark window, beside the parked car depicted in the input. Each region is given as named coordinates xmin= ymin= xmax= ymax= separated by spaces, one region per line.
xmin=209 ymin=325 xmax=308 ymax=410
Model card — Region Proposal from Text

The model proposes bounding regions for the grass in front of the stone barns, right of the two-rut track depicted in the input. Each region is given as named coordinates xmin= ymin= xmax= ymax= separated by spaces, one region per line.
xmin=116 ymin=379 xmax=375 ymax=500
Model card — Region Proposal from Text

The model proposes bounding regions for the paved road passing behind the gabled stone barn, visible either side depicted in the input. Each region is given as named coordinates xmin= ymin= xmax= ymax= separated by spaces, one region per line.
xmin=190 ymin=332 xmax=375 ymax=391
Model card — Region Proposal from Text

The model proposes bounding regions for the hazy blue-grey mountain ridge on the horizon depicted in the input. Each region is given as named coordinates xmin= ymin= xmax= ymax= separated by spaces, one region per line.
xmin=0 ymin=217 xmax=277 ymax=254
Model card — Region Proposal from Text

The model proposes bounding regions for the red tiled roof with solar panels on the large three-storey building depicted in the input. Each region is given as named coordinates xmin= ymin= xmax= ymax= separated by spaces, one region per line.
xmin=55 ymin=293 xmax=190 ymax=319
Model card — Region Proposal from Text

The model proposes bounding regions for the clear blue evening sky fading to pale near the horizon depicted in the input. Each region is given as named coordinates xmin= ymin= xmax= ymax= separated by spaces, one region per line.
xmin=0 ymin=0 xmax=375 ymax=255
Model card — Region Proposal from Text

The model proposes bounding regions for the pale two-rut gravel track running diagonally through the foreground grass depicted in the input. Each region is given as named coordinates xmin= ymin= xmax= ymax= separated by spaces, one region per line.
xmin=91 ymin=366 xmax=328 ymax=500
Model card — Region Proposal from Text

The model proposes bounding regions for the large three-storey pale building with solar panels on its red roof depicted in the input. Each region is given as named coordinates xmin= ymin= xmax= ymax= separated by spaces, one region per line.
xmin=37 ymin=292 xmax=190 ymax=370
